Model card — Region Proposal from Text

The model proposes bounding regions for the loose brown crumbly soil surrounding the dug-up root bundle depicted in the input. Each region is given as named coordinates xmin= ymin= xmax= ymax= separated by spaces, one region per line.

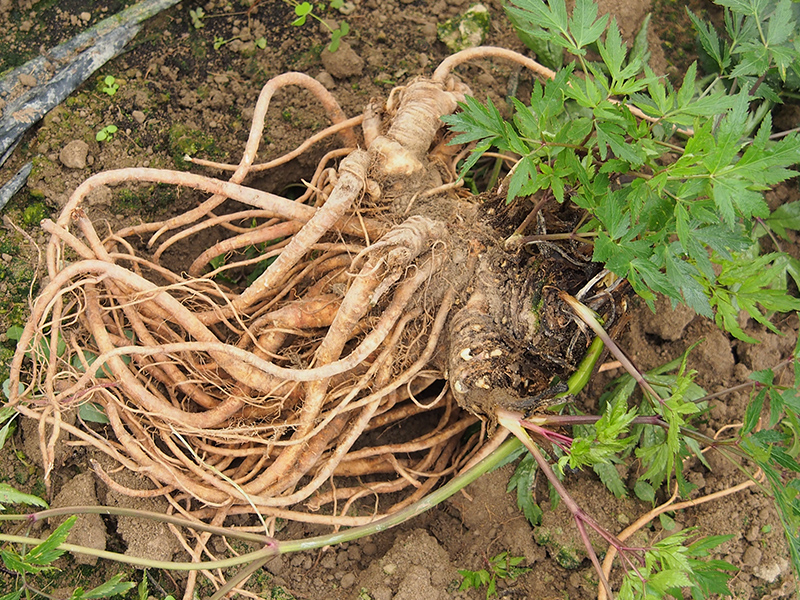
xmin=0 ymin=0 xmax=798 ymax=600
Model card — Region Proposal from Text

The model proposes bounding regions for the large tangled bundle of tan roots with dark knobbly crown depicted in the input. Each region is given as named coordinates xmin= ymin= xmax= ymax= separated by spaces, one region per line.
xmin=10 ymin=49 xmax=624 ymax=526
